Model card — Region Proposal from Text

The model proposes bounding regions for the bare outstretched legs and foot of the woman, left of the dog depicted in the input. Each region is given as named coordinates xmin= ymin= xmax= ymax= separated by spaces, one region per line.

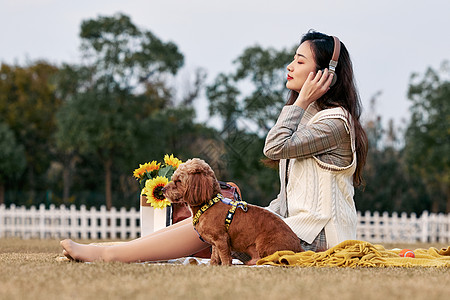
xmin=61 ymin=218 xmax=210 ymax=262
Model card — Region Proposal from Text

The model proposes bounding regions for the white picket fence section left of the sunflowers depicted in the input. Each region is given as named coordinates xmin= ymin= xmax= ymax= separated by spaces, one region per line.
xmin=0 ymin=204 xmax=141 ymax=239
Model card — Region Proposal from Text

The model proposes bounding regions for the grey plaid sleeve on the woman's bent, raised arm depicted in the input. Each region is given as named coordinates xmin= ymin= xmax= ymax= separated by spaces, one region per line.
xmin=264 ymin=105 xmax=348 ymax=159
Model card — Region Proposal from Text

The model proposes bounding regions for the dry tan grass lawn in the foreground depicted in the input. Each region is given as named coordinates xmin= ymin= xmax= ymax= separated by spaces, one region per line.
xmin=0 ymin=239 xmax=450 ymax=300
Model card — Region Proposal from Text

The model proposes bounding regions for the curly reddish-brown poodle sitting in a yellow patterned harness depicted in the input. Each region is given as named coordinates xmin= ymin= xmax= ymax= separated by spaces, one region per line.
xmin=164 ymin=158 xmax=303 ymax=265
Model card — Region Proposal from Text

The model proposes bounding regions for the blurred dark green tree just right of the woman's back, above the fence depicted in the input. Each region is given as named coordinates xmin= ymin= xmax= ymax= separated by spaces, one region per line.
xmin=355 ymin=92 xmax=430 ymax=213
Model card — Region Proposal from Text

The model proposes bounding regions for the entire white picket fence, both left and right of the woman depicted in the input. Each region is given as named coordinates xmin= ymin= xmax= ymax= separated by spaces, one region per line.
xmin=0 ymin=205 xmax=450 ymax=243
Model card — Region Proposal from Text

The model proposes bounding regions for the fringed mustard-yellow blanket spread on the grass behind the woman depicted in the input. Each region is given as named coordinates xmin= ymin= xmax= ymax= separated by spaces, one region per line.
xmin=257 ymin=240 xmax=450 ymax=268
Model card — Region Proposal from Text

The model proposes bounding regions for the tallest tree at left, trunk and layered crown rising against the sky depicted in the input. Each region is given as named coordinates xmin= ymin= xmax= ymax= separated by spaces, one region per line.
xmin=57 ymin=14 xmax=183 ymax=209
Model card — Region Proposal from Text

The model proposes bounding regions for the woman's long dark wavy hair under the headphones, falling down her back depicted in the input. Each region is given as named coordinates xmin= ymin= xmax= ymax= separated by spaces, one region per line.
xmin=287 ymin=30 xmax=368 ymax=186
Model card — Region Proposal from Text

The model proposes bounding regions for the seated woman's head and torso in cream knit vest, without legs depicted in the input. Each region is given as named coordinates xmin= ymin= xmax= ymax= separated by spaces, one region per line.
xmin=264 ymin=32 xmax=367 ymax=251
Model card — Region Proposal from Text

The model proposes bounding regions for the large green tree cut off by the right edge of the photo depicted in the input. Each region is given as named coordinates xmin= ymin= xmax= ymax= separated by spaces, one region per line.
xmin=405 ymin=61 xmax=450 ymax=212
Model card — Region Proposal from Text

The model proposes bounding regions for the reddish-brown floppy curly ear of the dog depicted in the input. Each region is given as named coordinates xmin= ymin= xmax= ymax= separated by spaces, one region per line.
xmin=183 ymin=172 xmax=215 ymax=206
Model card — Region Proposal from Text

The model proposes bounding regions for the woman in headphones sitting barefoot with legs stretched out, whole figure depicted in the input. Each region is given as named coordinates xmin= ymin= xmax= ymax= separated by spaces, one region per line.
xmin=61 ymin=32 xmax=367 ymax=262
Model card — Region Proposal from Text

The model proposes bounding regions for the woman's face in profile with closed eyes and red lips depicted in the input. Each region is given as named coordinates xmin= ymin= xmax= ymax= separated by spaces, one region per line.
xmin=286 ymin=41 xmax=317 ymax=92
